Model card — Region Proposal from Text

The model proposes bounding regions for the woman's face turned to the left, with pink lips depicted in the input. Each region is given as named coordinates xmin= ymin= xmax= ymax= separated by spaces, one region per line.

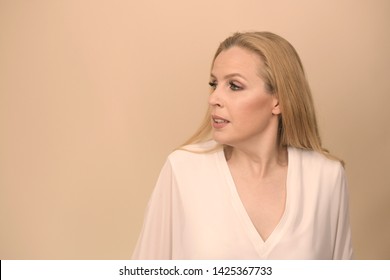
xmin=209 ymin=47 xmax=280 ymax=147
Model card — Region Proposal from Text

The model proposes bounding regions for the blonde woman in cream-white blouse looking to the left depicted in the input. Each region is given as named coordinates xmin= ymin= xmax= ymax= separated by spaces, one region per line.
xmin=133 ymin=32 xmax=352 ymax=259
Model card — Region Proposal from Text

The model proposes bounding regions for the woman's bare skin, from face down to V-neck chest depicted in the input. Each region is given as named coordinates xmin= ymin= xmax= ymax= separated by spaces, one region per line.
xmin=209 ymin=47 xmax=288 ymax=241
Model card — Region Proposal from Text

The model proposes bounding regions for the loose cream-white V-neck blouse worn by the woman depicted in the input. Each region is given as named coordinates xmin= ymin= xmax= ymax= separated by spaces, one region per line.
xmin=132 ymin=141 xmax=352 ymax=259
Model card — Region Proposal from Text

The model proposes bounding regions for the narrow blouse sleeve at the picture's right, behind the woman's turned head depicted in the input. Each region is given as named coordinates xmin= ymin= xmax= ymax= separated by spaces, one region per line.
xmin=332 ymin=165 xmax=353 ymax=260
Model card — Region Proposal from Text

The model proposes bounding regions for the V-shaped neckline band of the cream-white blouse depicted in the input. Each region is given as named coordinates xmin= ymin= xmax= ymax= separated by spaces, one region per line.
xmin=217 ymin=147 xmax=294 ymax=256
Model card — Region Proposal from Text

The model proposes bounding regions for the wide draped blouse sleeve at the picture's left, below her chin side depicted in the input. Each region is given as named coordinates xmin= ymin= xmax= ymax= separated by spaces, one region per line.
xmin=132 ymin=161 xmax=173 ymax=260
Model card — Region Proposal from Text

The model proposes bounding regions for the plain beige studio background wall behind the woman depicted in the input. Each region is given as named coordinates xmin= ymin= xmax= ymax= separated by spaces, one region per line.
xmin=0 ymin=0 xmax=390 ymax=259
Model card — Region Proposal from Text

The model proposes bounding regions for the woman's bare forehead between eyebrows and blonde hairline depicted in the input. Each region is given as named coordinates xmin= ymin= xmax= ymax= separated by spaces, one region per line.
xmin=212 ymin=47 xmax=262 ymax=76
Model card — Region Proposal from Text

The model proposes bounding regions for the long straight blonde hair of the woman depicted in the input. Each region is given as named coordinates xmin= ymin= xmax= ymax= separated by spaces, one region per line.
xmin=184 ymin=32 xmax=343 ymax=163
